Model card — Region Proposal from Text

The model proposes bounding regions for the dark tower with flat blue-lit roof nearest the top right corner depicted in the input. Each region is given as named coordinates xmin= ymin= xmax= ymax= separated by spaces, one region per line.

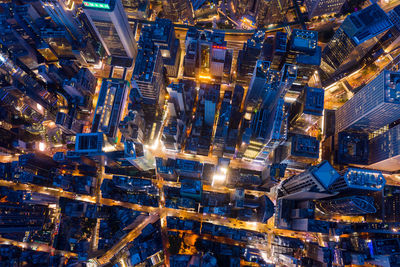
xmin=321 ymin=4 xmax=393 ymax=85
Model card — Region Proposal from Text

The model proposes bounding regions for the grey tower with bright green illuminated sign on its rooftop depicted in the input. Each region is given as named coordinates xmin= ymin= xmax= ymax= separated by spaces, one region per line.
xmin=83 ymin=0 xmax=137 ymax=67
